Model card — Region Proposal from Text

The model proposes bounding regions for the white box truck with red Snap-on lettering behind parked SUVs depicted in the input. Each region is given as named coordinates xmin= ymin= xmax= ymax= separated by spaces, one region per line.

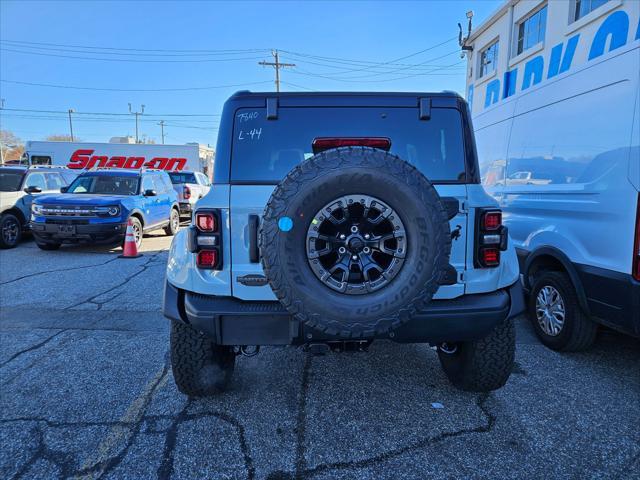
xmin=22 ymin=141 xmax=202 ymax=172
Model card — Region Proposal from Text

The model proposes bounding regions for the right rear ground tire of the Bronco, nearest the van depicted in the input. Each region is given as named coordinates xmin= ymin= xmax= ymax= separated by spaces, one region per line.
xmin=438 ymin=319 xmax=516 ymax=392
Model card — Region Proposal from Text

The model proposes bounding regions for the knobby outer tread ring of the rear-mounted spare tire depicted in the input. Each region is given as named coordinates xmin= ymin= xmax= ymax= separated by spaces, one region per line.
xmin=258 ymin=147 xmax=451 ymax=338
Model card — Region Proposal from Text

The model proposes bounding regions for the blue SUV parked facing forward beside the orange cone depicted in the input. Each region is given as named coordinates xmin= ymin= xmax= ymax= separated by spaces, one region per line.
xmin=31 ymin=169 xmax=180 ymax=250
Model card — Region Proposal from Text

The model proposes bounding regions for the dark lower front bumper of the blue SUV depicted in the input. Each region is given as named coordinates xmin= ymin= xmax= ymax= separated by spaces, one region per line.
xmin=30 ymin=222 xmax=127 ymax=244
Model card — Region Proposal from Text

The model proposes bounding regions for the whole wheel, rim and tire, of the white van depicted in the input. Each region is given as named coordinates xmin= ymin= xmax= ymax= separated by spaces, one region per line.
xmin=529 ymin=271 xmax=598 ymax=352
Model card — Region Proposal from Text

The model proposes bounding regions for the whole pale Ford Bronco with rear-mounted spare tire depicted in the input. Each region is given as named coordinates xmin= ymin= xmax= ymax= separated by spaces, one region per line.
xmin=163 ymin=92 xmax=523 ymax=396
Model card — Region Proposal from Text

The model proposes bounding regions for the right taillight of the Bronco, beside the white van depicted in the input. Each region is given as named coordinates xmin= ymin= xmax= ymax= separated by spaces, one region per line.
xmin=474 ymin=209 xmax=509 ymax=268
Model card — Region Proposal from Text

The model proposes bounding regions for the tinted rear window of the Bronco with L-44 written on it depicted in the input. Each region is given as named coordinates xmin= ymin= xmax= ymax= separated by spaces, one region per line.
xmin=231 ymin=107 xmax=465 ymax=183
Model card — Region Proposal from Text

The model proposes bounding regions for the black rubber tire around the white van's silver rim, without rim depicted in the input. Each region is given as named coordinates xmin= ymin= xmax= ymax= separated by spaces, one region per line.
xmin=529 ymin=271 xmax=598 ymax=352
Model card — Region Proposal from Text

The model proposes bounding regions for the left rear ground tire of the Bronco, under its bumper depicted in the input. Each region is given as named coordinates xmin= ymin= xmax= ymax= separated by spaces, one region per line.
xmin=170 ymin=320 xmax=236 ymax=397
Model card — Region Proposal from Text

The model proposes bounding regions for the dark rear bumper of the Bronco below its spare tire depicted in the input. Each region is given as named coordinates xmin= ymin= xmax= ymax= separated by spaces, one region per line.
xmin=163 ymin=281 xmax=524 ymax=345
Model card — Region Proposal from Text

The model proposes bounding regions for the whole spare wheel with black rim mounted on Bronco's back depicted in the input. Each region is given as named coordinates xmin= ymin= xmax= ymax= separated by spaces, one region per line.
xmin=260 ymin=147 xmax=451 ymax=338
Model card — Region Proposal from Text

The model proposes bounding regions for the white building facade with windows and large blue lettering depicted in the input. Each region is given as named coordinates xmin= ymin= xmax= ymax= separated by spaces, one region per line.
xmin=465 ymin=0 xmax=640 ymax=116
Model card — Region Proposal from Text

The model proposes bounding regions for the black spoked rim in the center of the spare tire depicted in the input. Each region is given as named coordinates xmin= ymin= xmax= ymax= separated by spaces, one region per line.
xmin=306 ymin=194 xmax=407 ymax=295
